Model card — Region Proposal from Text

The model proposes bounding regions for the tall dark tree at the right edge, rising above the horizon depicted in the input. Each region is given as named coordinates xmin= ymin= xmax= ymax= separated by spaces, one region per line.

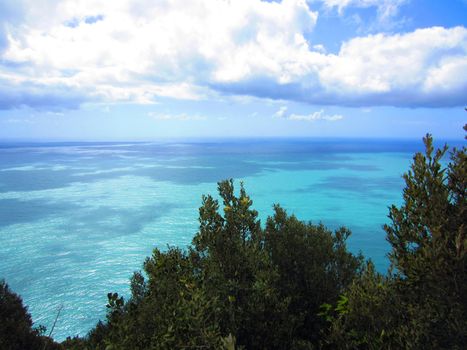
xmin=385 ymin=131 xmax=467 ymax=349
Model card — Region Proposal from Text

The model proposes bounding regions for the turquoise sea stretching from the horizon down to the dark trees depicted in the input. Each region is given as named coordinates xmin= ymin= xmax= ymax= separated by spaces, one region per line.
xmin=0 ymin=140 xmax=430 ymax=340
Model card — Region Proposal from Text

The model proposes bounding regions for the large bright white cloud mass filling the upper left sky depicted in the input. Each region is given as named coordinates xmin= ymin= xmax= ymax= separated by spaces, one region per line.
xmin=2 ymin=0 xmax=317 ymax=103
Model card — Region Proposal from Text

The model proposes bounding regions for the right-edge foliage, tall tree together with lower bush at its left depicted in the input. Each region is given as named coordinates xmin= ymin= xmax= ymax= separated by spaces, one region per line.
xmin=322 ymin=135 xmax=467 ymax=349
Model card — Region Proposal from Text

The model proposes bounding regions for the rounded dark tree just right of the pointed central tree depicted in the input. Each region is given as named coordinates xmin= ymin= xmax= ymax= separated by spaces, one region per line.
xmin=265 ymin=206 xmax=362 ymax=348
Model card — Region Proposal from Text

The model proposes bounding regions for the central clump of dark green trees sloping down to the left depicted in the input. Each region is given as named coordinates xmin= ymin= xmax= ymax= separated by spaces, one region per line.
xmin=75 ymin=180 xmax=362 ymax=349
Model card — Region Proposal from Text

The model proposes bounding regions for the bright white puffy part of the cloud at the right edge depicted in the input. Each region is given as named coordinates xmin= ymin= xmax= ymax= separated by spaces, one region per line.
xmin=318 ymin=27 xmax=467 ymax=105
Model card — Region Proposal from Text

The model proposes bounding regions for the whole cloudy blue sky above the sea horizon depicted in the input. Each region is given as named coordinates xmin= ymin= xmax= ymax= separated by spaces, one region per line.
xmin=0 ymin=0 xmax=467 ymax=141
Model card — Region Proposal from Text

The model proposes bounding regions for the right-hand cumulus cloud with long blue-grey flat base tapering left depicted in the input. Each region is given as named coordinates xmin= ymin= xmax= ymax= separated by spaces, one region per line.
xmin=217 ymin=27 xmax=467 ymax=107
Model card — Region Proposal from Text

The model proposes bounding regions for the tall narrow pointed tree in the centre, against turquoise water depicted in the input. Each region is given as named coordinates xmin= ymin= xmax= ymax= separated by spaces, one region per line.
xmin=193 ymin=180 xmax=284 ymax=349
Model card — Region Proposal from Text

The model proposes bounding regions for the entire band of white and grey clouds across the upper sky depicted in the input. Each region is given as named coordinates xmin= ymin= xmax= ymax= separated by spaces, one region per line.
xmin=0 ymin=0 xmax=467 ymax=108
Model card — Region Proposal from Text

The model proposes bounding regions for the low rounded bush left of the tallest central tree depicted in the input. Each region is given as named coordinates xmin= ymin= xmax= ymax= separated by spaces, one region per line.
xmin=94 ymin=248 xmax=220 ymax=349
